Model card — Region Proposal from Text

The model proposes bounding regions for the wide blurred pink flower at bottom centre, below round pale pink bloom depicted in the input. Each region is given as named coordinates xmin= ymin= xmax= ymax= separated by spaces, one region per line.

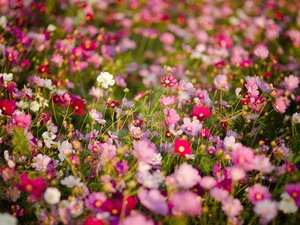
xmin=169 ymin=191 xmax=202 ymax=216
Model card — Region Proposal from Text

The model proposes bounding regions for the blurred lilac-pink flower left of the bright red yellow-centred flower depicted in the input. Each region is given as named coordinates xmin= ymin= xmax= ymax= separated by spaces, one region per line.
xmin=132 ymin=138 xmax=157 ymax=163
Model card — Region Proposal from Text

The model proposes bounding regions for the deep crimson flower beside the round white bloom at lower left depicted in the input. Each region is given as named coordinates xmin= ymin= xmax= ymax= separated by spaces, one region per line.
xmin=16 ymin=173 xmax=46 ymax=198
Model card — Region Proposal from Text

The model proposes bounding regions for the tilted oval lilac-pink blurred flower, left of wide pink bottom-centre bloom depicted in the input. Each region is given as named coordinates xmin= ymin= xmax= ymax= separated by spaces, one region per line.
xmin=138 ymin=189 xmax=169 ymax=215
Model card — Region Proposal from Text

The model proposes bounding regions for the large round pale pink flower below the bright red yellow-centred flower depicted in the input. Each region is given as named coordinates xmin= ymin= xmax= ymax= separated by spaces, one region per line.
xmin=174 ymin=163 xmax=201 ymax=188
